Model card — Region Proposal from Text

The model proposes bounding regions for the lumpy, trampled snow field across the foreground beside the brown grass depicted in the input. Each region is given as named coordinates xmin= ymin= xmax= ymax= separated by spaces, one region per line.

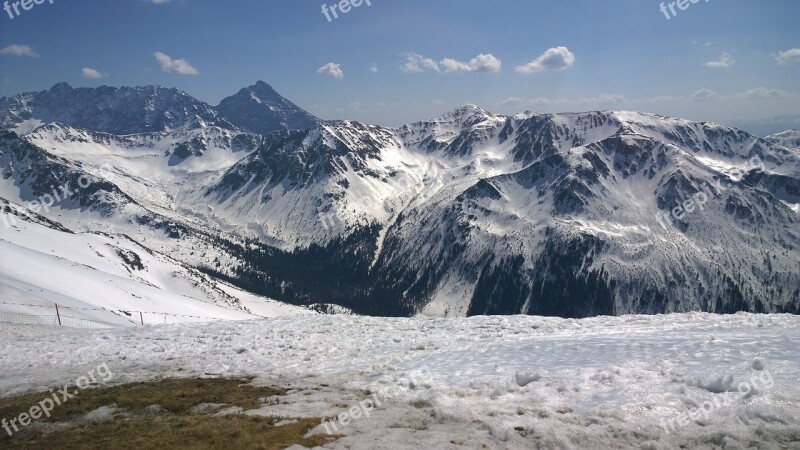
xmin=0 ymin=313 xmax=800 ymax=449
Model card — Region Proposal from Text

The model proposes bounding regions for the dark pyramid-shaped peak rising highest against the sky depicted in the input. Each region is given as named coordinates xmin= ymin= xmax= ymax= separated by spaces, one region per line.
xmin=216 ymin=81 xmax=321 ymax=134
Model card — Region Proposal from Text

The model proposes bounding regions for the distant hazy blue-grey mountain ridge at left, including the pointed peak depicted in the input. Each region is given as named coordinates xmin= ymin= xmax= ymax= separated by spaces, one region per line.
xmin=0 ymin=81 xmax=321 ymax=135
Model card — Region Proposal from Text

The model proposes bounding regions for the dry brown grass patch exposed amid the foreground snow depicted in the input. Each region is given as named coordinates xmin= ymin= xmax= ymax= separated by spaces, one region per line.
xmin=0 ymin=378 xmax=336 ymax=450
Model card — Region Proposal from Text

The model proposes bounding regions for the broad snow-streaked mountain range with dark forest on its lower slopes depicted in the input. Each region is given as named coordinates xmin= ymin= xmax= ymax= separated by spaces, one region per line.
xmin=0 ymin=84 xmax=800 ymax=317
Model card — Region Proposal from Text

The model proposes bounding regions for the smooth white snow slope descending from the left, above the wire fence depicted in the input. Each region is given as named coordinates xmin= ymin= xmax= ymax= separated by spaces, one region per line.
xmin=0 ymin=206 xmax=312 ymax=325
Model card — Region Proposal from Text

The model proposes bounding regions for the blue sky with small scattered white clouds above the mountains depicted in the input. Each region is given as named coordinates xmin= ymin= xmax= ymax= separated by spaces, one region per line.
xmin=0 ymin=0 xmax=800 ymax=134
